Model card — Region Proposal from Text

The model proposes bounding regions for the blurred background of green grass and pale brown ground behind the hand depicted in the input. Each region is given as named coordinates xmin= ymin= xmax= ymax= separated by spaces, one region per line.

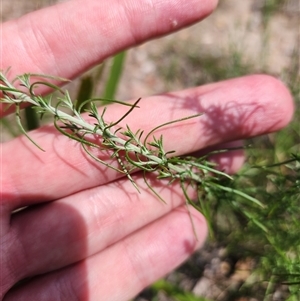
xmin=1 ymin=0 xmax=300 ymax=301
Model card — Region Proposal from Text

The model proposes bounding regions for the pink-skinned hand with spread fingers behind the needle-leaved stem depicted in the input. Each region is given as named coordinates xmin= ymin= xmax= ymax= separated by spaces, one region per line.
xmin=0 ymin=0 xmax=293 ymax=301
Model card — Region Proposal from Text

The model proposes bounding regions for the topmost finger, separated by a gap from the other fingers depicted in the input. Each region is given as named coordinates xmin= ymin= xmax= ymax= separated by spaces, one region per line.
xmin=0 ymin=0 xmax=217 ymax=79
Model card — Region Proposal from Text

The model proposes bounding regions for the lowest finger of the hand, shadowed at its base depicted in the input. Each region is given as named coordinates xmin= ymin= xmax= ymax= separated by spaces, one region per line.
xmin=4 ymin=207 xmax=207 ymax=301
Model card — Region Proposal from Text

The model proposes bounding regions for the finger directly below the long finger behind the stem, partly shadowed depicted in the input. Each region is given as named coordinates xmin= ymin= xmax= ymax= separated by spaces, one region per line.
xmin=2 ymin=173 xmax=195 ymax=288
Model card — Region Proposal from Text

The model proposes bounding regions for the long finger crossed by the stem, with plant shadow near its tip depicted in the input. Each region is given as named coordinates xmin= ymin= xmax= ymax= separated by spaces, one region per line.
xmin=1 ymin=75 xmax=293 ymax=209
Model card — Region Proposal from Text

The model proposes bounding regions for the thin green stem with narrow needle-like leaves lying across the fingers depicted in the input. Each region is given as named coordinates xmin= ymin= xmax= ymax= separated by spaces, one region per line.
xmin=0 ymin=72 xmax=265 ymax=237
